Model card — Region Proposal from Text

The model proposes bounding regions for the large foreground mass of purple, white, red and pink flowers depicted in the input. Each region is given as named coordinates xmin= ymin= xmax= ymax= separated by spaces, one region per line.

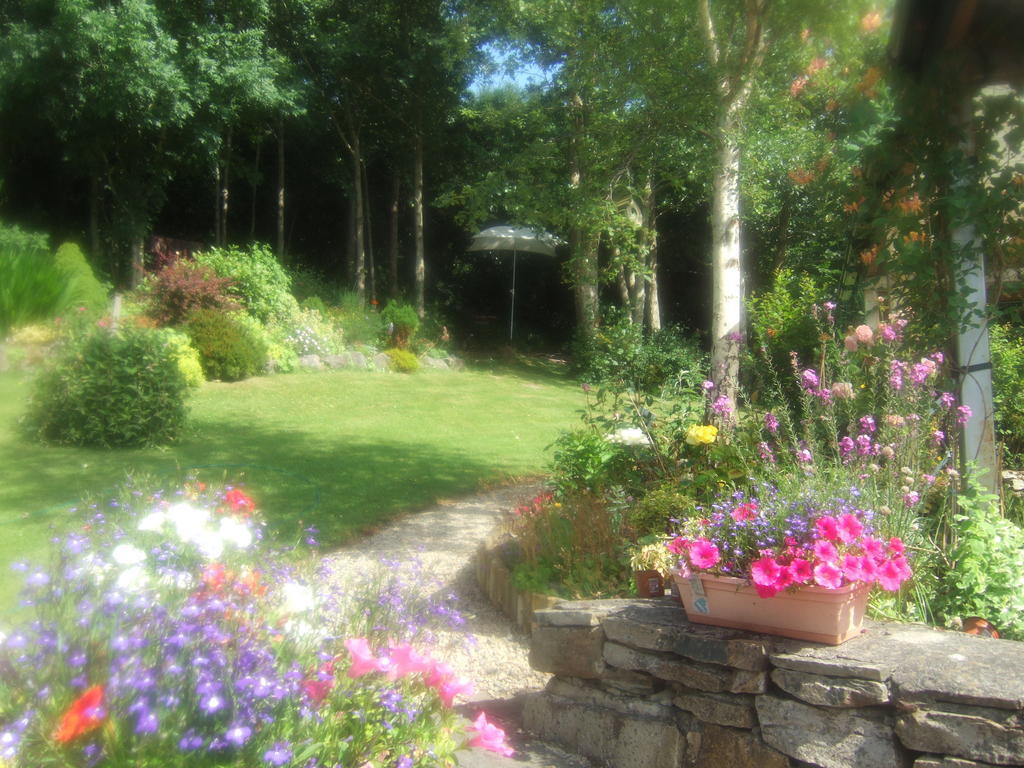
xmin=0 ymin=486 xmax=509 ymax=768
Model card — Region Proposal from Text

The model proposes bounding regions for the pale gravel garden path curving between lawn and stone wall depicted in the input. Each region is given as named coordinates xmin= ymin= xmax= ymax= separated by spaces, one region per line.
xmin=325 ymin=484 xmax=590 ymax=768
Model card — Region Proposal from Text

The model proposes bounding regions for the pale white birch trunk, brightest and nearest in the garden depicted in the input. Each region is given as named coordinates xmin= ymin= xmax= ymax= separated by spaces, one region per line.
xmin=711 ymin=109 xmax=743 ymax=426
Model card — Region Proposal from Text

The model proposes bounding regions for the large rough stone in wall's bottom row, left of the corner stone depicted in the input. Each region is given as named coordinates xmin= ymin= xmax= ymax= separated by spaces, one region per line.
xmin=756 ymin=694 xmax=909 ymax=768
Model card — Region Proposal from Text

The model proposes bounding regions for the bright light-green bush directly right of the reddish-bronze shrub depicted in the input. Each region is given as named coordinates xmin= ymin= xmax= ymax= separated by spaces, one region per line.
xmin=196 ymin=244 xmax=299 ymax=323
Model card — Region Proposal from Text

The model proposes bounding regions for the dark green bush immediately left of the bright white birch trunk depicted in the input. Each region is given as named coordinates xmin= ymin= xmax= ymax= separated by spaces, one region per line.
xmin=575 ymin=312 xmax=708 ymax=394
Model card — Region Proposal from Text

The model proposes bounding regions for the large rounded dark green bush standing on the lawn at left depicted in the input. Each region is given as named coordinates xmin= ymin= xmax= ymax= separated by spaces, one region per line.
xmin=26 ymin=329 xmax=187 ymax=447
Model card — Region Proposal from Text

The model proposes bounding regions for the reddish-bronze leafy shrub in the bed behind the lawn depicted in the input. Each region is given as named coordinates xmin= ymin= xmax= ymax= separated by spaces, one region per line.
xmin=143 ymin=259 xmax=238 ymax=326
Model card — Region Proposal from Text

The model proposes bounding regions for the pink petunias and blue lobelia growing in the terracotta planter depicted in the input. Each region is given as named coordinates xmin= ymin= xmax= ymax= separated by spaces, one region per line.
xmin=666 ymin=486 xmax=911 ymax=597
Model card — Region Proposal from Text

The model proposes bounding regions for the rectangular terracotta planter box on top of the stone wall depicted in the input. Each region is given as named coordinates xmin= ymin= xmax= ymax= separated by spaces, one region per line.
xmin=674 ymin=573 xmax=870 ymax=645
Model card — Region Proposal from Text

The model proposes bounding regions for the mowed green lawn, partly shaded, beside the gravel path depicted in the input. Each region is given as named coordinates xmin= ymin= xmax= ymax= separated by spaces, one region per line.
xmin=0 ymin=371 xmax=583 ymax=608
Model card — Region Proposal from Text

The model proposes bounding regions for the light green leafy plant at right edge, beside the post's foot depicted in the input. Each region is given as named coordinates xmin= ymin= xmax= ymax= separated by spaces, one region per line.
xmin=936 ymin=479 xmax=1024 ymax=640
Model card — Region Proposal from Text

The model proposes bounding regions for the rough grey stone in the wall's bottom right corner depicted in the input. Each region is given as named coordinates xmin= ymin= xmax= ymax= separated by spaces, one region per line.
xmin=896 ymin=705 xmax=1024 ymax=765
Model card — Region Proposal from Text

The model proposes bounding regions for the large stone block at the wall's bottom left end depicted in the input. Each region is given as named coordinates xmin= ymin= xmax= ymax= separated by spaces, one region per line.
xmin=523 ymin=692 xmax=687 ymax=768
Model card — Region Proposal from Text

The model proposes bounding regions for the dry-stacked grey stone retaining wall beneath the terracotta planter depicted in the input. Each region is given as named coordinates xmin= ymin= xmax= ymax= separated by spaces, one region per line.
xmin=523 ymin=598 xmax=1024 ymax=768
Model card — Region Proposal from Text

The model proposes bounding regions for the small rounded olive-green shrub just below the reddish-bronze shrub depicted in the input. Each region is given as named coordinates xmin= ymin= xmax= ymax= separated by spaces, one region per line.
xmin=185 ymin=309 xmax=266 ymax=381
